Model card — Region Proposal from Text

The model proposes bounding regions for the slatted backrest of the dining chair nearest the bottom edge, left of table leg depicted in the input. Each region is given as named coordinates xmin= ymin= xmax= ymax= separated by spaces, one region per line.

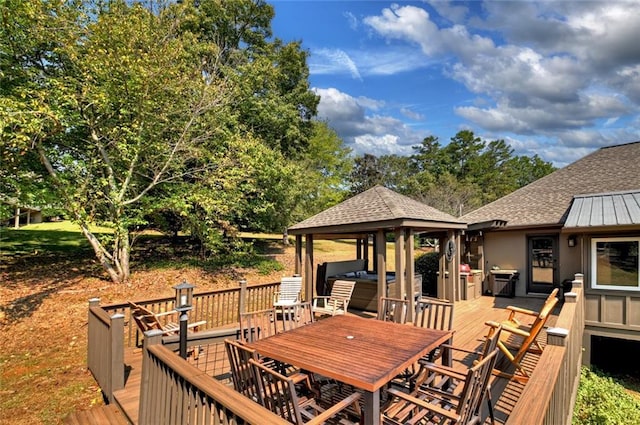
xmin=249 ymin=359 xmax=303 ymax=424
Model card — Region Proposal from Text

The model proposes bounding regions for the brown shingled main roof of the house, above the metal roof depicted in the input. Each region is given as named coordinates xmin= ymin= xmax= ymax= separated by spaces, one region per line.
xmin=460 ymin=141 xmax=640 ymax=228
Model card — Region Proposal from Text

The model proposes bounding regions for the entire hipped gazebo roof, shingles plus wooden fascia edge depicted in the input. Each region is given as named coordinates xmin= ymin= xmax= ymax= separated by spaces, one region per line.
xmin=289 ymin=186 xmax=466 ymax=234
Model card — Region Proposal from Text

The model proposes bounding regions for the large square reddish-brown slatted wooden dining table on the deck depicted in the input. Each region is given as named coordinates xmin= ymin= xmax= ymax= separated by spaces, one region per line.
xmin=248 ymin=315 xmax=451 ymax=424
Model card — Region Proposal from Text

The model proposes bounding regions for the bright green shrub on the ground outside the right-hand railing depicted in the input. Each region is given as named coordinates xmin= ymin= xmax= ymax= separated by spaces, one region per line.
xmin=572 ymin=367 xmax=640 ymax=425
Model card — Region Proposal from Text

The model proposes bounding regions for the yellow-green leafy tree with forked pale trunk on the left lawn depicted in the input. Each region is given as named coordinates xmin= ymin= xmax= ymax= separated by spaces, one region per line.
xmin=0 ymin=1 xmax=228 ymax=282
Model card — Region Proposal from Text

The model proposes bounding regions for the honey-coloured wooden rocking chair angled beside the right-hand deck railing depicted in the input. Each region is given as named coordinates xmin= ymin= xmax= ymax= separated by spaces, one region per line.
xmin=486 ymin=288 xmax=559 ymax=384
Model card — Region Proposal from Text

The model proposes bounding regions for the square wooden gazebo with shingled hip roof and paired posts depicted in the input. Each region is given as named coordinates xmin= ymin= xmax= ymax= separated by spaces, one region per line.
xmin=288 ymin=186 xmax=467 ymax=320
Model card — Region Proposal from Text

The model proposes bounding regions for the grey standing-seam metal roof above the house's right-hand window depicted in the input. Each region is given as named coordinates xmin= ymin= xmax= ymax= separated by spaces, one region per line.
xmin=564 ymin=190 xmax=640 ymax=228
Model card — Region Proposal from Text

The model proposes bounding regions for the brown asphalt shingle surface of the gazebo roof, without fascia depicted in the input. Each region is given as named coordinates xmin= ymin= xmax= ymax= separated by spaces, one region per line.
xmin=289 ymin=186 xmax=464 ymax=233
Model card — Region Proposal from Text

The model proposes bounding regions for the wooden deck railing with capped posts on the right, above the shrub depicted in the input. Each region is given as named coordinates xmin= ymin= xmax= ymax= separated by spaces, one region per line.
xmin=507 ymin=274 xmax=585 ymax=425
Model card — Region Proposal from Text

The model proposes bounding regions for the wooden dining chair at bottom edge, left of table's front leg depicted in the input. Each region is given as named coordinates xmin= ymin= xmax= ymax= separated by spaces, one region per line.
xmin=249 ymin=359 xmax=362 ymax=425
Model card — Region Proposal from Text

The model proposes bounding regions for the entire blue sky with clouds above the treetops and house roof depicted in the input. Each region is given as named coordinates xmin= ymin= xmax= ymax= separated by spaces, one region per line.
xmin=267 ymin=0 xmax=640 ymax=167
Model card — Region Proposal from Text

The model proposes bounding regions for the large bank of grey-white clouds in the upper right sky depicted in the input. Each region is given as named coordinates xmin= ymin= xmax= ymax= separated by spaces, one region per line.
xmin=363 ymin=1 xmax=640 ymax=151
